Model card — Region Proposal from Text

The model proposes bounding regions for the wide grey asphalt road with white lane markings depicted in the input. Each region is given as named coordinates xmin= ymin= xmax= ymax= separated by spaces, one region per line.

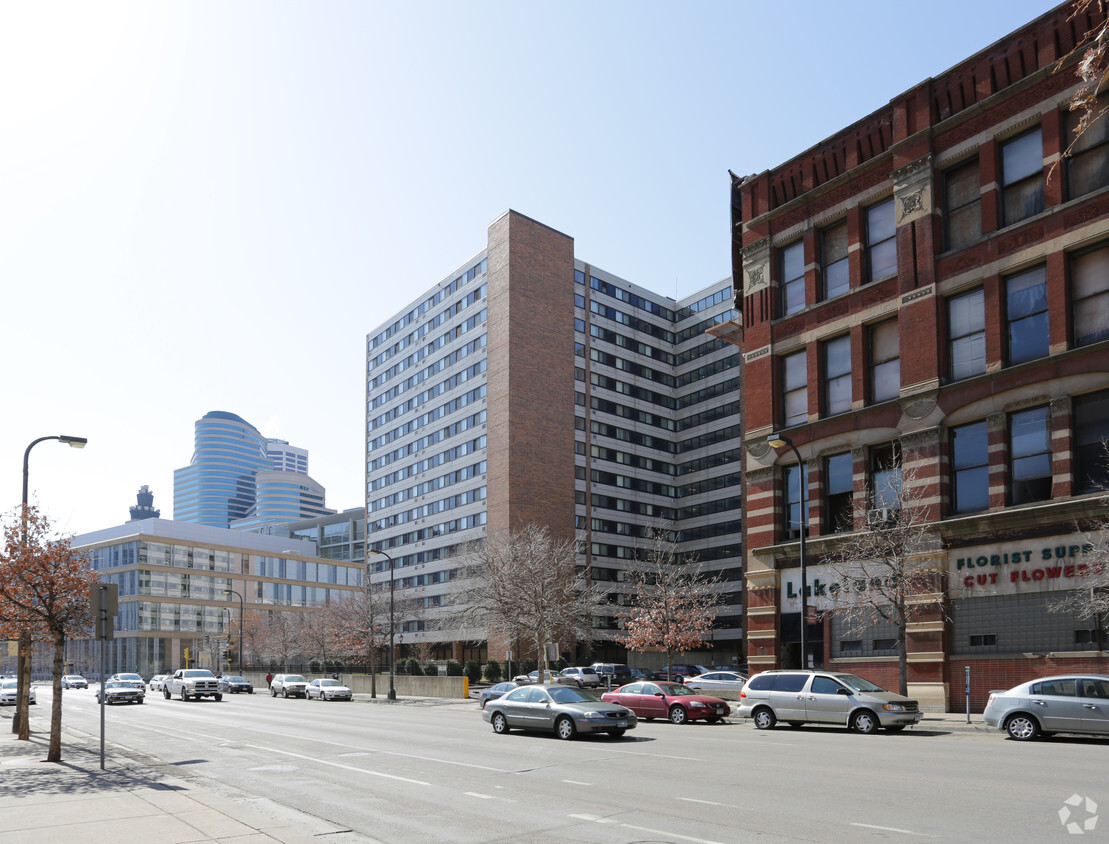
xmin=26 ymin=688 xmax=1109 ymax=844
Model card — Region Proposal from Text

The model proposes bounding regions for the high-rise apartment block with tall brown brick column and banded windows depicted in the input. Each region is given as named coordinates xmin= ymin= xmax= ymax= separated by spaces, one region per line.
xmin=365 ymin=211 xmax=742 ymax=661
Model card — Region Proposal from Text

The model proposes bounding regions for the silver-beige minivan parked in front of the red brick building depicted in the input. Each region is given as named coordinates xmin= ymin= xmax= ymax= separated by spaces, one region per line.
xmin=737 ymin=670 xmax=920 ymax=734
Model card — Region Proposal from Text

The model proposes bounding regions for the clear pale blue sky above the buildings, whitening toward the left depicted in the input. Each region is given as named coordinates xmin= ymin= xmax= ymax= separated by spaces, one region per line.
xmin=0 ymin=0 xmax=1069 ymax=533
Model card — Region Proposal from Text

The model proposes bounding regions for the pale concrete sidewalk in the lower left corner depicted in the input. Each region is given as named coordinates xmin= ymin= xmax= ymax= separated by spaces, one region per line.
xmin=0 ymin=713 xmax=369 ymax=844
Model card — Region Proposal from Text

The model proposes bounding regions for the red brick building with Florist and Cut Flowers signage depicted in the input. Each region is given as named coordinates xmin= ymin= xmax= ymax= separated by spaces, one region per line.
xmin=732 ymin=3 xmax=1109 ymax=711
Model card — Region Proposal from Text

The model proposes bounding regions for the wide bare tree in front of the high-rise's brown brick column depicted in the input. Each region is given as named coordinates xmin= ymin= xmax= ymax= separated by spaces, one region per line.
xmin=457 ymin=525 xmax=602 ymax=680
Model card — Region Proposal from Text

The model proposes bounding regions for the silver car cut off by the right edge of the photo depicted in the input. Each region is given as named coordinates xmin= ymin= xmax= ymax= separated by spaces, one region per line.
xmin=981 ymin=674 xmax=1109 ymax=741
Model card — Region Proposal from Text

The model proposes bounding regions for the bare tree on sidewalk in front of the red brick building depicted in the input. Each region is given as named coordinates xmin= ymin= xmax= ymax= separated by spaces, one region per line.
xmin=821 ymin=458 xmax=943 ymax=694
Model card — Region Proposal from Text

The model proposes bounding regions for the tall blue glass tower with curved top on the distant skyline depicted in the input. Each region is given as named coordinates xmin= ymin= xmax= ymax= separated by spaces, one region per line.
xmin=173 ymin=410 xmax=273 ymax=528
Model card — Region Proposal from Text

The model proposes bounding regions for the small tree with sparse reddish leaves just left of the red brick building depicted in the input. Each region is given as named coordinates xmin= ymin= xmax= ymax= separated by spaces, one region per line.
xmin=615 ymin=529 xmax=720 ymax=679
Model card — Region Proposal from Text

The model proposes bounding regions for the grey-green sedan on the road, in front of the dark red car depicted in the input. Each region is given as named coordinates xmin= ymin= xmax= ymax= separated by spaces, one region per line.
xmin=481 ymin=685 xmax=637 ymax=739
